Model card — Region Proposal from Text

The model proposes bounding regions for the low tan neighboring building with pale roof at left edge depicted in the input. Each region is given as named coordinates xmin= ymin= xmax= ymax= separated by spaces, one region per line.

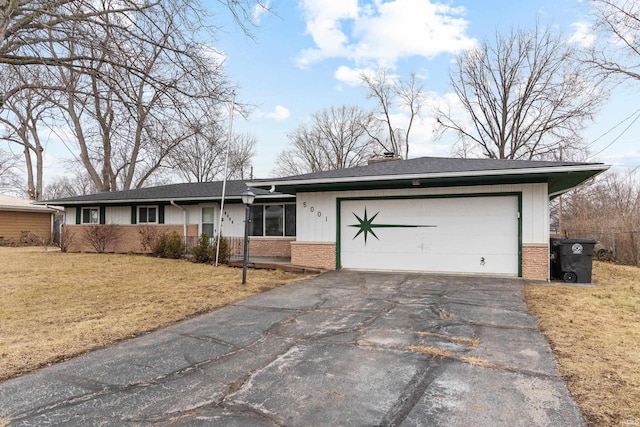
xmin=0 ymin=194 xmax=56 ymax=244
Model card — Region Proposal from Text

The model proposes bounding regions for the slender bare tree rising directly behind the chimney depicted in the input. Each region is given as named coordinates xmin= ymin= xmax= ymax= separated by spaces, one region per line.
xmin=360 ymin=68 xmax=424 ymax=159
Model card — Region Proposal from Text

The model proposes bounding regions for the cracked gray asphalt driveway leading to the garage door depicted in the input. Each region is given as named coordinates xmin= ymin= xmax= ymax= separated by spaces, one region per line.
xmin=0 ymin=271 xmax=585 ymax=427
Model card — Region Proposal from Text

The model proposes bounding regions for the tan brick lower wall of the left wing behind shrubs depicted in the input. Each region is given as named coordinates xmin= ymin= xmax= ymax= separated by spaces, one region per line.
xmin=62 ymin=224 xmax=198 ymax=253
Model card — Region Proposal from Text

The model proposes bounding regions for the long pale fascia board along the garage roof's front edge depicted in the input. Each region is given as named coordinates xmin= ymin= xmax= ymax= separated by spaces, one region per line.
xmin=247 ymin=165 xmax=609 ymax=188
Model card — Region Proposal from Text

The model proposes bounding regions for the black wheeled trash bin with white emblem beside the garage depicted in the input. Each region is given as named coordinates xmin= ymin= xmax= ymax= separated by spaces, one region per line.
xmin=551 ymin=239 xmax=596 ymax=283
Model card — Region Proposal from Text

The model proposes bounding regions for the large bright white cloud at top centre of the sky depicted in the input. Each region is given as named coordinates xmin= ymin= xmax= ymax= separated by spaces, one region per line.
xmin=297 ymin=0 xmax=476 ymax=68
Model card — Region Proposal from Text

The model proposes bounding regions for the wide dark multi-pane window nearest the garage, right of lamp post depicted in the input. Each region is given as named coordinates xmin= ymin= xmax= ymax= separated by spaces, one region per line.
xmin=249 ymin=204 xmax=296 ymax=237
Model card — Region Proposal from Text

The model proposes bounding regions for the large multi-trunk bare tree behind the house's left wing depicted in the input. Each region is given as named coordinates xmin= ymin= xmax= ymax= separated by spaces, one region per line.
xmin=7 ymin=0 xmax=240 ymax=194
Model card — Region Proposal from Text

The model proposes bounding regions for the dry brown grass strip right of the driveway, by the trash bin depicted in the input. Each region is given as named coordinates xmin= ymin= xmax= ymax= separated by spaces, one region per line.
xmin=525 ymin=262 xmax=640 ymax=427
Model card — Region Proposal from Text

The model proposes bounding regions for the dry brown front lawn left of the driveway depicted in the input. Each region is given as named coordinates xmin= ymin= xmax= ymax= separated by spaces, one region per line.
xmin=0 ymin=247 xmax=304 ymax=380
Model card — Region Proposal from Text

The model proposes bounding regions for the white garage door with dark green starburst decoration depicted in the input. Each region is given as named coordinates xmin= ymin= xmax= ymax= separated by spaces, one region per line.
xmin=339 ymin=195 xmax=519 ymax=276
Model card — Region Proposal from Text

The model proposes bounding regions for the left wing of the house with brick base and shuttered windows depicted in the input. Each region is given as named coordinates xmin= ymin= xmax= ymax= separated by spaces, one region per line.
xmin=41 ymin=181 xmax=296 ymax=257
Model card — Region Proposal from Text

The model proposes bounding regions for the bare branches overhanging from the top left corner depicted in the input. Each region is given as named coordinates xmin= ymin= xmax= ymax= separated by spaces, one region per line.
xmin=0 ymin=0 xmax=268 ymax=106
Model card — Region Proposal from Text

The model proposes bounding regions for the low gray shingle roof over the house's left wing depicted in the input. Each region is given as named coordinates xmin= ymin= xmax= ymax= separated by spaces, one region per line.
xmin=40 ymin=181 xmax=289 ymax=206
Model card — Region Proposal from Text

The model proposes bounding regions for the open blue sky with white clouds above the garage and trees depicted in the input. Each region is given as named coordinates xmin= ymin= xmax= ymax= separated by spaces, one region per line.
xmin=211 ymin=0 xmax=640 ymax=178
